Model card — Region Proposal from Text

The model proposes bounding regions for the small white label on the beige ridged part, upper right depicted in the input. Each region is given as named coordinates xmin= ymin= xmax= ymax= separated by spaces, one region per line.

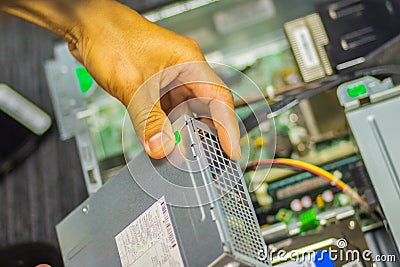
xmin=293 ymin=27 xmax=320 ymax=68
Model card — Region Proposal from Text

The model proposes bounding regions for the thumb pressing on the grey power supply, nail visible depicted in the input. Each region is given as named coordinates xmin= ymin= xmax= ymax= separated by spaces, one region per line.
xmin=128 ymin=94 xmax=175 ymax=159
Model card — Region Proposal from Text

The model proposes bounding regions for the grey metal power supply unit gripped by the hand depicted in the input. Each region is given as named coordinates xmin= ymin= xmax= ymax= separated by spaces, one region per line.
xmin=57 ymin=115 xmax=270 ymax=267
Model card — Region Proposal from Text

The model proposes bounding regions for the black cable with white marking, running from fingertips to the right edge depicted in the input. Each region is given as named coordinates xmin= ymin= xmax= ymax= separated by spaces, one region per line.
xmin=240 ymin=65 xmax=400 ymax=136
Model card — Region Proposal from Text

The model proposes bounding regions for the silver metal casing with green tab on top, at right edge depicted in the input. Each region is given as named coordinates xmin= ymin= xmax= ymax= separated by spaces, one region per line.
xmin=338 ymin=76 xmax=400 ymax=251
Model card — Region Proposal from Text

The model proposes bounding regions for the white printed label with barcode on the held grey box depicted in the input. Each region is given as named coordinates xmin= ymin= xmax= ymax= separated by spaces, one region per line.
xmin=115 ymin=197 xmax=184 ymax=267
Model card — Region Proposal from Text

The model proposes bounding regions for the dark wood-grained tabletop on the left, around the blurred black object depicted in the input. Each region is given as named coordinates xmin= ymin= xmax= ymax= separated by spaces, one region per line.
xmin=0 ymin=17 xmax=87 ymax=247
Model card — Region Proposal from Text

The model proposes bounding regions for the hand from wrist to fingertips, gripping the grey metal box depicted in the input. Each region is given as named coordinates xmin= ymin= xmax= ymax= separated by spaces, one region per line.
xmin=69 ymin=1 xmax=240 ymax=159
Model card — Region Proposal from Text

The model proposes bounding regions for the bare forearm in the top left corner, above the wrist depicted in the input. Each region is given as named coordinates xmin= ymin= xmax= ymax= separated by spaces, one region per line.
xmin=0 ymin=0 xmax=114 ymax=42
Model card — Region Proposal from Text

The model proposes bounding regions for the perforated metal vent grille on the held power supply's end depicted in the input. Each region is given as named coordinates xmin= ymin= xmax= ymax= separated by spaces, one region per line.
xmin=197 ymin=128 xmax=268 ymax=263
